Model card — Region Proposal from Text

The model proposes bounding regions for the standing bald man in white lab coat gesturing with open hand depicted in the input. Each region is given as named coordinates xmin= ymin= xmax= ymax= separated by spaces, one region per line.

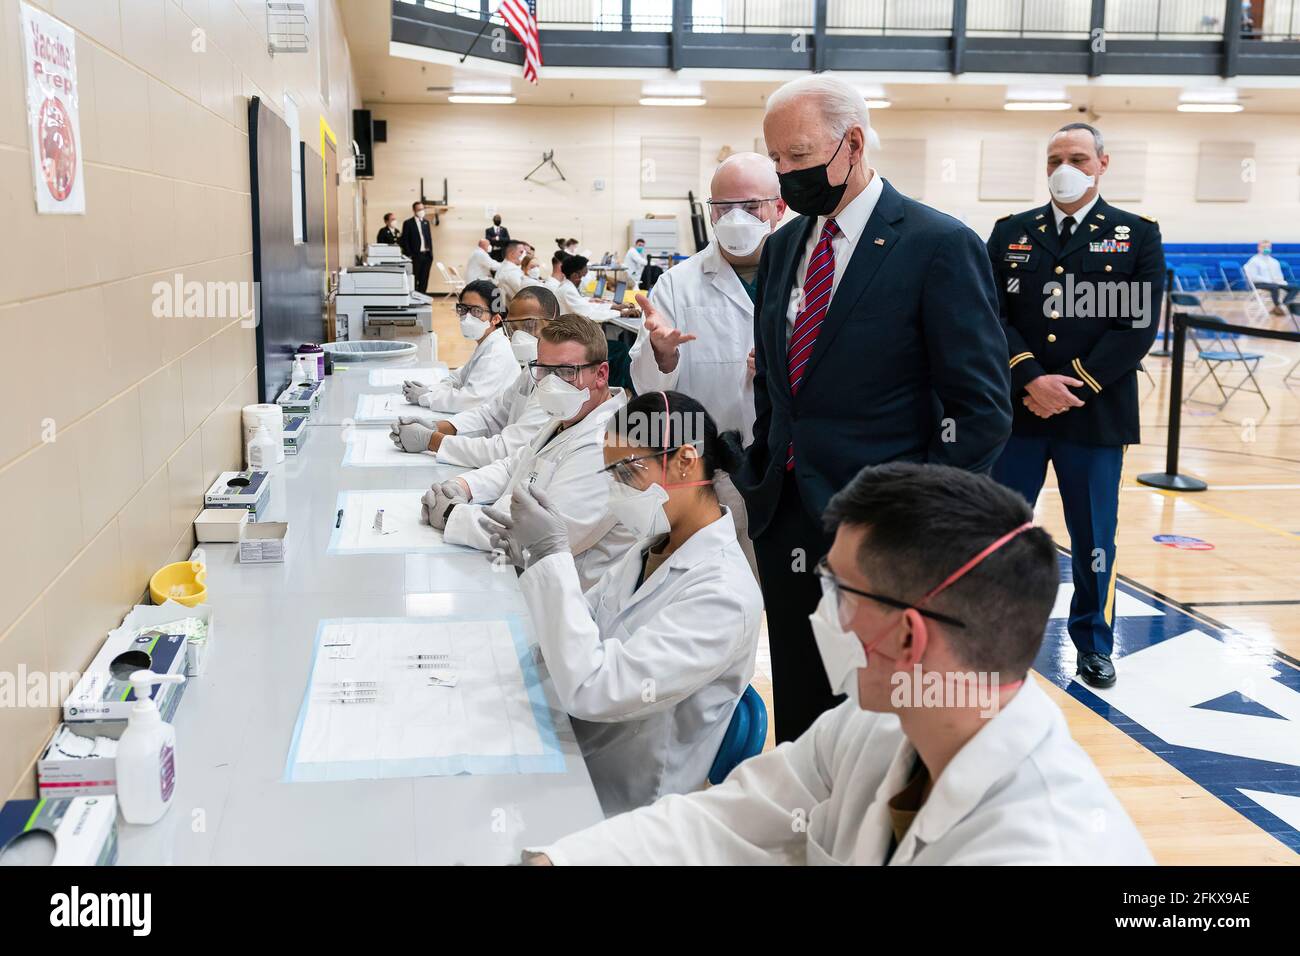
xmin=631 ymin=152 xmax=785 ymax=574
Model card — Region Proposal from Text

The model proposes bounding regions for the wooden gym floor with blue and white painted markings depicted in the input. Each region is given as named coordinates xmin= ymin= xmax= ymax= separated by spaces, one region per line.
xmin=421 ymin=287 xmax=1300 ymax=865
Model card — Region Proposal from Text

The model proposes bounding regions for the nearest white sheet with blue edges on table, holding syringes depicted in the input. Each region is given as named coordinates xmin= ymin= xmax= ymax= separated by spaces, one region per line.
xmin=285 ymin=618 xmax=564 ymax=780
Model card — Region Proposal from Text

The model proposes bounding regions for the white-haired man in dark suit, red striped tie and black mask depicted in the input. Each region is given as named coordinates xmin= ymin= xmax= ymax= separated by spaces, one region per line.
xmin=736 ymin=74 xmax=1011 ymax=741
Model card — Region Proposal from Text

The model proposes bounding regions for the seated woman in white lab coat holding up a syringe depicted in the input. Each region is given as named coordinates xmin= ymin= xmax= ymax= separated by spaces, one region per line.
xmin=486 ymin=392 xmax=763 ymax=816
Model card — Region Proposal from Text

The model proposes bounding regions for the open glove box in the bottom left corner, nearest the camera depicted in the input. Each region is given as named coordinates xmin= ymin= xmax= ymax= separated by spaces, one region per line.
xmin=0 ymin=796 xmax=117 ymax=866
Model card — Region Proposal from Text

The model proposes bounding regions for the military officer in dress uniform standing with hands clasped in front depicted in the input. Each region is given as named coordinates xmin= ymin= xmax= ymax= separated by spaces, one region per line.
xmin=988 ymin=122 xmax=1165 ymax=687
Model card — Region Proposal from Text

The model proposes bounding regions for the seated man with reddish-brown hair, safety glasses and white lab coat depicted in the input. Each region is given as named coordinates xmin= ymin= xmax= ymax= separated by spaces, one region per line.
xmin=423 ymin=315 xmax=633 ymax=588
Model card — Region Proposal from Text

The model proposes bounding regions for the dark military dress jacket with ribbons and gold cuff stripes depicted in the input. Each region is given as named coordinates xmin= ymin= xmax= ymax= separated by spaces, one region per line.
xmin=988 ymin=196 xmax=1165 ymax=445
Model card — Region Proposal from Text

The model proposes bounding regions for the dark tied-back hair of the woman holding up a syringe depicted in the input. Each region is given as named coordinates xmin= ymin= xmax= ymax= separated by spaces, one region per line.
xmin=610 ymin=392 xmax=745 ymax=493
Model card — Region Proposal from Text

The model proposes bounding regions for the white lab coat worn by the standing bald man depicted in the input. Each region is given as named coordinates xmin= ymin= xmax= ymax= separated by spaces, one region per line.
xmin=631 ymin=242 xmax=754 ymax=445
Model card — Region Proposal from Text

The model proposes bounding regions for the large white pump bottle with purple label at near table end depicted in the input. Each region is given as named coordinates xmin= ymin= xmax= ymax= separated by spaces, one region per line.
xmin=117 ymin=671 xmax=185 ymax=823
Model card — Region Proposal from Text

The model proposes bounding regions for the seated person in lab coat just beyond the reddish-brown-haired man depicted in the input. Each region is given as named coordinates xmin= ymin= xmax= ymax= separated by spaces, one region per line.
xmin=391 ymin=286 xmax=559 ymax=468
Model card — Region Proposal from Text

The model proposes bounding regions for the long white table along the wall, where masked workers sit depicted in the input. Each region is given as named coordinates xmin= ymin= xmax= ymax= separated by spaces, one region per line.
xmin=118 ymin=337 xmax=602 ymax=864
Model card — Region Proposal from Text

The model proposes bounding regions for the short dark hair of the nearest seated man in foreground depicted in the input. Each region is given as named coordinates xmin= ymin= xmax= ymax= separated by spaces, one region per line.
xmin=824 ymin=462 xmax=1060 ymax=679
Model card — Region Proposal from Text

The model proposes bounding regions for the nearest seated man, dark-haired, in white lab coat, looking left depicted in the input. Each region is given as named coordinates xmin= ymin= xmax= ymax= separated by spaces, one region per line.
xmin=525 ymin=462 xmax=1152 ymax=866
